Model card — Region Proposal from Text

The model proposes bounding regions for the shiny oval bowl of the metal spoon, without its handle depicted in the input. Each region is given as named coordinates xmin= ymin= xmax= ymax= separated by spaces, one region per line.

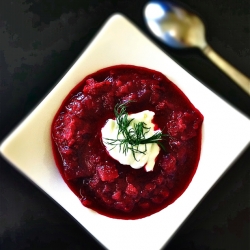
xmin=144 ymin=2 xmax=207 ymax=49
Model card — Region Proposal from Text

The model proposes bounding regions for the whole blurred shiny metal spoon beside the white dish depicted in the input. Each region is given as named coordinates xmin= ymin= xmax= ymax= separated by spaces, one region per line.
xmin=144 ymin=1 xmax=250 ymax=95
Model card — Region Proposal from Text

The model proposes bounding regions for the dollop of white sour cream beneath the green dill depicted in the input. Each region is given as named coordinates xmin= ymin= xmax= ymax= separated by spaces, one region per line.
xmin=101 ymin=110 xmax=160 ymax=172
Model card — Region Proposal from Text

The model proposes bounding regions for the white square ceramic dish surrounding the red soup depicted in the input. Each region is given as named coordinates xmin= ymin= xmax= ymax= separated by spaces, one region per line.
xmin=0 ymin=14 xmax=250 ymax=250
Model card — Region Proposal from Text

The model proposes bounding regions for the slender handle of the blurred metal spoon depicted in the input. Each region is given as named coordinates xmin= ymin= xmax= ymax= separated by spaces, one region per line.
xmin=202 ymin=45 xmax=250 ymax=95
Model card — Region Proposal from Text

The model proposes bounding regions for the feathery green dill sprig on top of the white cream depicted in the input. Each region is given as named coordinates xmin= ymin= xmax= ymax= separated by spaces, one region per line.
xmin=105 ymin=101 xmax=167 ymax=161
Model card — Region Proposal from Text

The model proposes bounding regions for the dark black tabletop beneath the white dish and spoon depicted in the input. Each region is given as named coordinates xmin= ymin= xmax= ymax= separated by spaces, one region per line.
xmin=0 ymin=0 xmax=250 ymax=250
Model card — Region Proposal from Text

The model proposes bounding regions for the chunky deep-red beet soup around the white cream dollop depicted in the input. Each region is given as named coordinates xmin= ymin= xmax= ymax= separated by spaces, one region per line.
xmin=51 ymin=65 xmax=203 ymax=219
